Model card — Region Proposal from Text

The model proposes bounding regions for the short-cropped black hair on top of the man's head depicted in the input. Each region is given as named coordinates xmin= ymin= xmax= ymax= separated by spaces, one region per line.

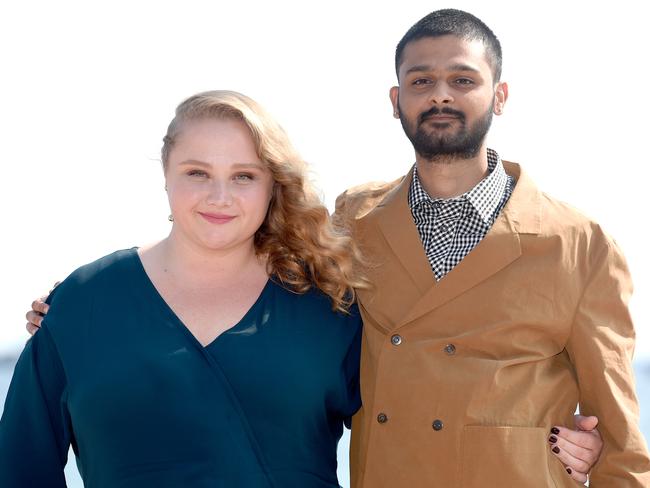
xmin=395 ymin=8 xmax=502 ymax=81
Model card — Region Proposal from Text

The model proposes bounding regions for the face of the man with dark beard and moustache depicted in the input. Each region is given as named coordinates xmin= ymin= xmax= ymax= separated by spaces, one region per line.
xmin=390 ymin=35 xmax=507 ymax=161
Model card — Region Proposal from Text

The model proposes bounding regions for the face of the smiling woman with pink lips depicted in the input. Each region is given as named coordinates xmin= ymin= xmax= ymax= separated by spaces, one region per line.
xmin=165 ymin=119 xmax=273 ymax=251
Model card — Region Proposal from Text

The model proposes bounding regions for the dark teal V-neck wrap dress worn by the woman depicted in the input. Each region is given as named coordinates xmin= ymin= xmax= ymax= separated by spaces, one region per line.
xmin=0 ymin=249 xmax=361 ymax=488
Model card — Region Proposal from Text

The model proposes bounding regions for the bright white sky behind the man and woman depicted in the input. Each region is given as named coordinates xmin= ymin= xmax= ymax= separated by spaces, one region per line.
xmin=0 ymin=0 xmax=650 ymax=483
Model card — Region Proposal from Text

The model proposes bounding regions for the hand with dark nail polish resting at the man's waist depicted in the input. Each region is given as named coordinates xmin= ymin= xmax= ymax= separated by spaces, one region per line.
xmin=548 ymin=415 xmax=603 ymax=483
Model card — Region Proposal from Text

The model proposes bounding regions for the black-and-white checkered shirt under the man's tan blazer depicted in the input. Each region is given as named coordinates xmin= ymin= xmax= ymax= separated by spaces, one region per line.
xmin=408 ymin=149 xmax=515 ymax=281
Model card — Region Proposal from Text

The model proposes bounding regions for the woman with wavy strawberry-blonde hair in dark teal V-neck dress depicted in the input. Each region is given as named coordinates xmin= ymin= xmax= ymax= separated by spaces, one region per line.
xmin=0 ymin=91 xmax=365 ymax=488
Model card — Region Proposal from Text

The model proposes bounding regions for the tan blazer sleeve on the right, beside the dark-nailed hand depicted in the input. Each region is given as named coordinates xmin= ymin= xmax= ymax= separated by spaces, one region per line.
xmin=567 ymin=234 xmax=650 ymax=488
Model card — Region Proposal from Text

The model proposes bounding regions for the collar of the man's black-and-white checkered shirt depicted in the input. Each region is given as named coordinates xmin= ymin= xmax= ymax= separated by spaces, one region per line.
xmin=408 ymin=148 xmax=508 ymax=225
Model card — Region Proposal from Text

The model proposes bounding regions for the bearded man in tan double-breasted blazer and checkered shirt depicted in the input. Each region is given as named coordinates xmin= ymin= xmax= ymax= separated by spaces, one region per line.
xmin=337 ymin=10 xmax=650 ymax=488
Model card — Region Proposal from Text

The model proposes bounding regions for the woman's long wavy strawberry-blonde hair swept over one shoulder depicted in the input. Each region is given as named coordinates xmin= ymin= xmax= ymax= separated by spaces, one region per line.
xmin=161 ymin=90 xmax=368 ymax=311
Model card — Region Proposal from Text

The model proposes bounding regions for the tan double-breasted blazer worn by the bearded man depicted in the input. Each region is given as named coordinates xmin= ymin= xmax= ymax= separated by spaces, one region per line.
xmin=337 ymin=163 xmax=650 ymax=488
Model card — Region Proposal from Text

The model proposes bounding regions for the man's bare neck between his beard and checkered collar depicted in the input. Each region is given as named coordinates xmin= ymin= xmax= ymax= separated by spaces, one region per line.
xmin=416 ymin=146 xmax=488 ymax=199
